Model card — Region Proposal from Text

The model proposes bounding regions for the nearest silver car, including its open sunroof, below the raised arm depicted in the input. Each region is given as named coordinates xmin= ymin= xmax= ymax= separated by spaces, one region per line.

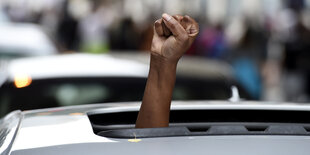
xmin=0 ymin=101 xmax=310 ymax=155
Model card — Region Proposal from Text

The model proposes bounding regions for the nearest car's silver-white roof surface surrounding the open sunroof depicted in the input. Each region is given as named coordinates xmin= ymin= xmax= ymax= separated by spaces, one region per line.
xmin=8 ymin=101 xmax=310 ymax=154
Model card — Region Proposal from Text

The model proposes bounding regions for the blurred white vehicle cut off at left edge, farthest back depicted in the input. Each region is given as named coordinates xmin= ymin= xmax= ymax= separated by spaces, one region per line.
xmin=0 ymin=22 xmax=58 ymax=60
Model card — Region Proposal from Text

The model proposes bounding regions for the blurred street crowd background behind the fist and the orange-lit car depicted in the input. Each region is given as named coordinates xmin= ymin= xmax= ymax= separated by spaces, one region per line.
xmin=0 ymin=0 xmax=310 ymax=116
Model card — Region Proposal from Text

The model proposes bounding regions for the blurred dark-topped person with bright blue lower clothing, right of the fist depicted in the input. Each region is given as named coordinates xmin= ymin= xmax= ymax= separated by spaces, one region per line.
xmin=225 ymin=17 xmax=267 ymax=99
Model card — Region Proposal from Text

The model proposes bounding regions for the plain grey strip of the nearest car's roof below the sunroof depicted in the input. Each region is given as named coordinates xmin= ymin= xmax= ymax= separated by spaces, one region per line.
xmin=12 ymin=136 xmax=310 ymax=155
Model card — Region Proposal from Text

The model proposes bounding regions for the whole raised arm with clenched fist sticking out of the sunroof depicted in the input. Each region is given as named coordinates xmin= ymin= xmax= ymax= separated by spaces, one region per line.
xmin=136 ymin=14 xmax=199 ymax=128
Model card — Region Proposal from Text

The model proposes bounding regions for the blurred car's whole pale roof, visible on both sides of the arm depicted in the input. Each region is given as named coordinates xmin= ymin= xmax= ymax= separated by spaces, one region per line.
xmin=6 ymin=52 xmax=234 ymax=81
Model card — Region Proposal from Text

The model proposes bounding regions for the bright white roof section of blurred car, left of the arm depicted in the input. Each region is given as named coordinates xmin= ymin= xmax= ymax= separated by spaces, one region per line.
xmin=7 ymin=54 xmax=148 ymax=80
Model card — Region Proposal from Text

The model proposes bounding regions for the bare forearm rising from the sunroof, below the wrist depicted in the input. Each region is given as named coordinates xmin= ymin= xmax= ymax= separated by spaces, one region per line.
xmin=136 ymin=56 xmax=177 ymax=128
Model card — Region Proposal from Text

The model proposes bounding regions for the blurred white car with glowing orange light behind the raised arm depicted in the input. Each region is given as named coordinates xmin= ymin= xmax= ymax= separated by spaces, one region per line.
xmin=0 ymin=54 xmax=252 ymax=116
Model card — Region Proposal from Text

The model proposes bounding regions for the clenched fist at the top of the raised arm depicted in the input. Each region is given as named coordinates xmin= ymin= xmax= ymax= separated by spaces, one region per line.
xmin=151 ymin=13 xmax=199 ymax=63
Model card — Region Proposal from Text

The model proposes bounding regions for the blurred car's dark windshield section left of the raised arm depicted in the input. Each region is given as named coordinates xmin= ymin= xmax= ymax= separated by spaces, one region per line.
xmin=0 ymin=77 xmax=145 ymax=115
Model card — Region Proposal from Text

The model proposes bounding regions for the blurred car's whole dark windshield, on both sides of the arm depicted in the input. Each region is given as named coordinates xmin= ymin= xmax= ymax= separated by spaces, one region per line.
xmin=0 ymin=77 xmax=251 ymax=116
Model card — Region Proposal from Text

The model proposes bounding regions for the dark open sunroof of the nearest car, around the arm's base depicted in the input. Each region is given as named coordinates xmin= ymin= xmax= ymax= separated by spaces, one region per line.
xmin=88 ymin=110 xmax=310 ymax=138
